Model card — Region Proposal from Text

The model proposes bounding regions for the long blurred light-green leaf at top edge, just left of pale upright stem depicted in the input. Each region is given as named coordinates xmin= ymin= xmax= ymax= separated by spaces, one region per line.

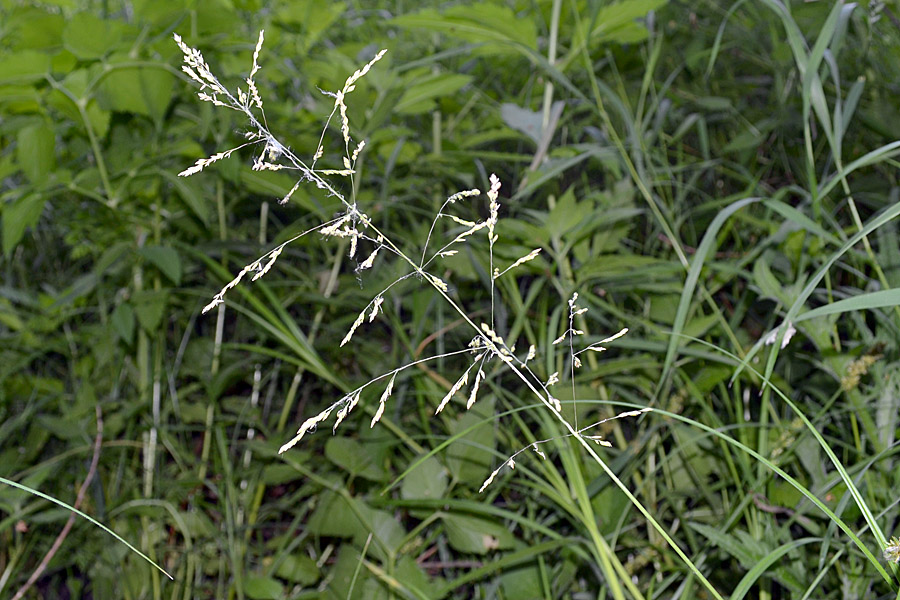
xmin=392 ymin=2 xmax=537 ymax=54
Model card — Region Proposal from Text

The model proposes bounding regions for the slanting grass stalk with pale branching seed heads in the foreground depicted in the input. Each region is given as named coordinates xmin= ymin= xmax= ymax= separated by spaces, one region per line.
xmin=175 ymin=32 xmax=721 ymax=598
